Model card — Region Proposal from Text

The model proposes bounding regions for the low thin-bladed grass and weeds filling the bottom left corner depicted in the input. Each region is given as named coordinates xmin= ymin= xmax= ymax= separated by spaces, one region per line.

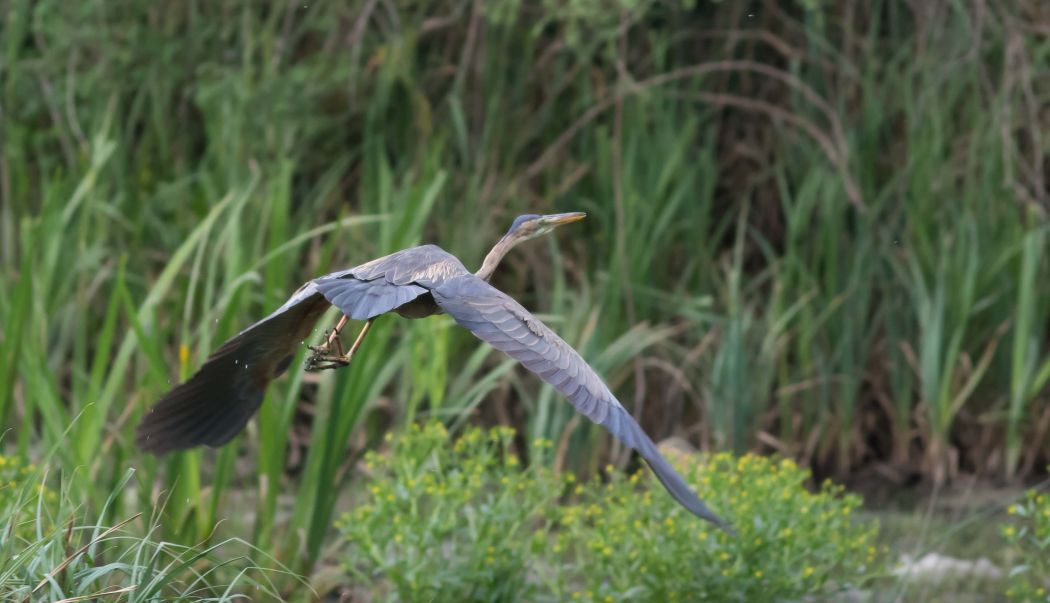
xmin=0 ymin=468 xmax=287 ymax=603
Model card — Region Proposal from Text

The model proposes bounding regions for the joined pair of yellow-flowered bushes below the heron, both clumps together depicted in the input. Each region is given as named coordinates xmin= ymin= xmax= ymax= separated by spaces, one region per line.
xmin=338 ymin=424 xmax=881 ymax=602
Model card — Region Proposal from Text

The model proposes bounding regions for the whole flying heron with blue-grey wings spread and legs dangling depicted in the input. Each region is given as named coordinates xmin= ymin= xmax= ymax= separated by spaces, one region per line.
xmin=135 ymin=212 xmax=732 ymax=532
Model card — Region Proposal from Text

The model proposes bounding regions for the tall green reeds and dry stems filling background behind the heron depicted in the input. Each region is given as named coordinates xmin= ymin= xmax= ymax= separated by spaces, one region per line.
xmin=0 ymin=0 xmax=1050 ymax=600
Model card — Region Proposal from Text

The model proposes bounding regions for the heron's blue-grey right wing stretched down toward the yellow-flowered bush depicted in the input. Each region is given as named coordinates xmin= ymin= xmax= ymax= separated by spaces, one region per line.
xmin=431 ymin=274 xmax=729 ymax=528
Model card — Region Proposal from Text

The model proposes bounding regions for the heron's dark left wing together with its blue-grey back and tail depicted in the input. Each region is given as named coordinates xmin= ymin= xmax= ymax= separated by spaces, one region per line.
xmin=135 ymin=245 xmax=466 ymax=454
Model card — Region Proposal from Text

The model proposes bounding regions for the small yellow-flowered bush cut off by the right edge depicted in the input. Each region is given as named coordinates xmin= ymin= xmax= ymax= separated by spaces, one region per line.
xmin=1002 ymin=490 xmax=1050 ymax=602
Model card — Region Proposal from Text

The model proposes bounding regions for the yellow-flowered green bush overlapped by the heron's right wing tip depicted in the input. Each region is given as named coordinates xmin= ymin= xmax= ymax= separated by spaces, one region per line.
xmin=553 ymin=453 xmax=882 ymax=602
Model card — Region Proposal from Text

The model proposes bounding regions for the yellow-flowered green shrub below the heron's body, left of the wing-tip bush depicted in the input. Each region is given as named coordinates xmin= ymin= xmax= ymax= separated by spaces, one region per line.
xmin=337 ymin=423 xmax=563 ymax=601
